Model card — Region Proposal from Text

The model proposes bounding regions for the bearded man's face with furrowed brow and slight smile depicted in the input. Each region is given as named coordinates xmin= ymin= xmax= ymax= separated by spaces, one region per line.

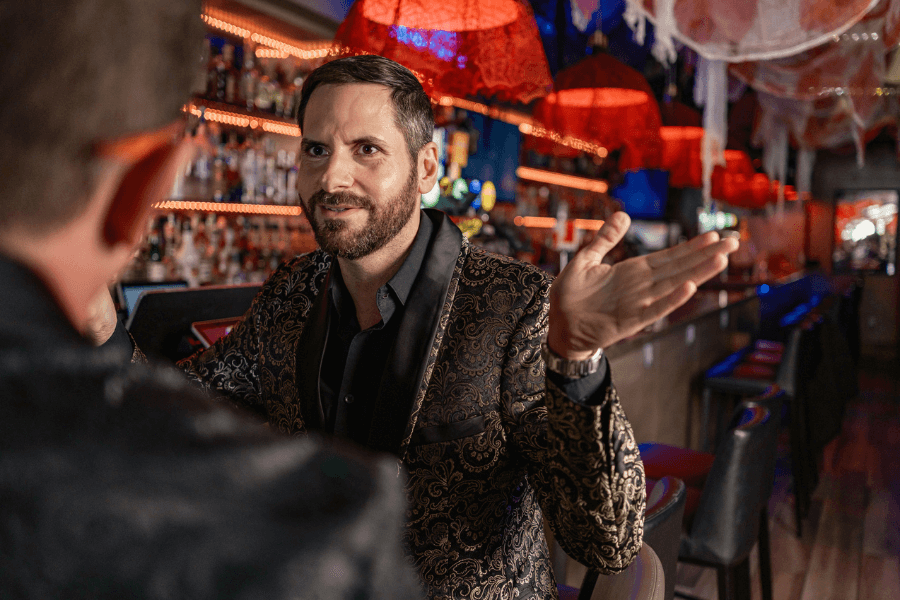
xmin=298 ymin=84 xmax=419 ymax=260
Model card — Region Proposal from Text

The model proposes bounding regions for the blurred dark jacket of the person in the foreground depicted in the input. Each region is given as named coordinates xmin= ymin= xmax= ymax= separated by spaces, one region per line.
xmin=0 ymin=258 xmax=424 ymax=600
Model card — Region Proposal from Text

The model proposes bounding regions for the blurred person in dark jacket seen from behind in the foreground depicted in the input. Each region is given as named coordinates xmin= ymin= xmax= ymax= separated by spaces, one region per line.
xmin=0 ymin=0 xmax=422 ymax=600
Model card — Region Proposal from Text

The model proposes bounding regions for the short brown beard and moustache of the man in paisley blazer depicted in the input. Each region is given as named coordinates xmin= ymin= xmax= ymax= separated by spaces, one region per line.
xmin=300 ymin=166 xmax=419 ymax=260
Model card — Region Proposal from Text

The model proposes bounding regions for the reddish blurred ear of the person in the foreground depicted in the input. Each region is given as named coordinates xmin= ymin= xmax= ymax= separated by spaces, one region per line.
xmin=103 ymin=144 xmax=184 ymax=246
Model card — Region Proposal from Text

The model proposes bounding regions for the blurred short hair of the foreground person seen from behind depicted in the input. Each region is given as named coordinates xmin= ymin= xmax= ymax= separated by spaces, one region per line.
xmin=0 ymin=0 xmax=203 ymax=232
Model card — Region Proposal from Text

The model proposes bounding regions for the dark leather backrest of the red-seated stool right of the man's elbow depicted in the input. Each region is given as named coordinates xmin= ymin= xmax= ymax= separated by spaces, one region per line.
xmin=685 ymin=401 xmax=777 ymax=565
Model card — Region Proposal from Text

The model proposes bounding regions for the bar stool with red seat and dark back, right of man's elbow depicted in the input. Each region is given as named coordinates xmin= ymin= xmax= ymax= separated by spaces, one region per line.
xmin=641 ymin=389 xmax=783 ymax=600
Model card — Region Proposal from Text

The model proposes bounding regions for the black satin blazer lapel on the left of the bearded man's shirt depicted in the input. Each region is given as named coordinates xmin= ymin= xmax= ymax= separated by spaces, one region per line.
xmin=297 ymin=263 xmax=334 ymax=431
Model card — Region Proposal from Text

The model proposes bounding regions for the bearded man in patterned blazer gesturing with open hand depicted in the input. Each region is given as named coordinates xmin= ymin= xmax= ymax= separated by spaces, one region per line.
xmin=93 ymin=56 xmax=736 ymax=599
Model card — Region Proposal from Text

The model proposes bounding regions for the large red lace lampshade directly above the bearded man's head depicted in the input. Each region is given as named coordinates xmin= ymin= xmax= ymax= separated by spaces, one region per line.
xmin=335 ymin=0 xmax=552 ymax=104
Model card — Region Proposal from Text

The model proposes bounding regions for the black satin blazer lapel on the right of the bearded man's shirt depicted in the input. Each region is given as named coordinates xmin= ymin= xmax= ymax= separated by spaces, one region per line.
xmin=367 ymin=210 xmax=463 ymax=458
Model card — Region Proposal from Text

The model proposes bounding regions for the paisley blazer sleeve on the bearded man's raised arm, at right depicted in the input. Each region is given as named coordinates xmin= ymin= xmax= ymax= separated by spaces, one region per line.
xmin=501 ymin=281 xmax=646 ymax=574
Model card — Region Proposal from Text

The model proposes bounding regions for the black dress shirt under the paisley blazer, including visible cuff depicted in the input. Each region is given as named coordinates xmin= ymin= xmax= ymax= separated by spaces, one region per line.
xmin=319 ymin=215 xmax=608 ymax=445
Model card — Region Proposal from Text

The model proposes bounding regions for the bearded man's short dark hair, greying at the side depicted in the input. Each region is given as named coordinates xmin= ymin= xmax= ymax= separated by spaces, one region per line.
xmin=297 ymin=54 xmax=434 ymax=160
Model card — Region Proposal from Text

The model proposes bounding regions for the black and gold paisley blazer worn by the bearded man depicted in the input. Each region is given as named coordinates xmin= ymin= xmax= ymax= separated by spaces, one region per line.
xmin=182 ymin=211 xmax=645 ymax=599
